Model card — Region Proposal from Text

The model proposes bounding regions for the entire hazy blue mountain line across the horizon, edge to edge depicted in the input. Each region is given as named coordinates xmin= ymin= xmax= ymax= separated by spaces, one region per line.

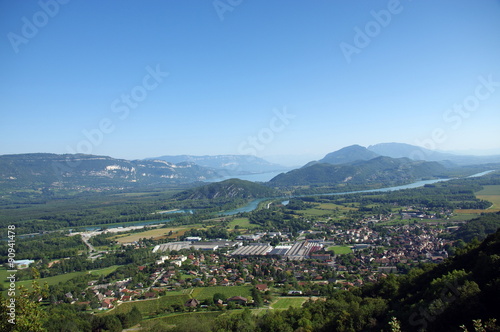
xmin=0 ymin=143 xmax=500 ymax=189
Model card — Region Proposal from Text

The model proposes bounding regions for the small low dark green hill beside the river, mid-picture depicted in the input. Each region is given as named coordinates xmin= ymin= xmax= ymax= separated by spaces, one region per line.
xmin=174 ymin=179 xmax=277 ymax=200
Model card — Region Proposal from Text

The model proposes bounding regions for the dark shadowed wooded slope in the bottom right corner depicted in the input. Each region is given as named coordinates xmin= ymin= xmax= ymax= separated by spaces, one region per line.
xmin=376 ymin=222 xmax=500 ymax=331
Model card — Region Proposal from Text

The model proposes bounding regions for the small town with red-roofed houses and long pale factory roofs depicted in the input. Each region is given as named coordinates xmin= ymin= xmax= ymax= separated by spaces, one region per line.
xmin=39 ymin=208 xmax=458 ymax=311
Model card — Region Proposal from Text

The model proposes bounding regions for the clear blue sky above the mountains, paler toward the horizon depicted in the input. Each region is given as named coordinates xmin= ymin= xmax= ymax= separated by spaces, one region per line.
xmin=0 ymin=0 xmax=500 ymax=164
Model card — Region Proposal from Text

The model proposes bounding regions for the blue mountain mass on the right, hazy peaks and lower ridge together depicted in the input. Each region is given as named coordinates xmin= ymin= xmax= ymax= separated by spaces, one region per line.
xmin=269 ymin=143 xmax=500 ymax=188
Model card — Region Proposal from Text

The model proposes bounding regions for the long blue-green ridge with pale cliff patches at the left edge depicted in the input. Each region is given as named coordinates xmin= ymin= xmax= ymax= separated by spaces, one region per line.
xmin=0 ymin=153 xmax=220 ymax=189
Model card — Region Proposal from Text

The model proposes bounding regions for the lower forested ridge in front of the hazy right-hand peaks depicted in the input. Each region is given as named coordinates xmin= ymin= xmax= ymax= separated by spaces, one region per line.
xmin=269 ymin=157 xmax=448 ymax=187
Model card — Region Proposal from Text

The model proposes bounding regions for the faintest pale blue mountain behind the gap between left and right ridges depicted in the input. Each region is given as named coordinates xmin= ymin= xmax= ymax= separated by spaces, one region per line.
xmin=147 ymin=155 xmax=287 ymax=176
